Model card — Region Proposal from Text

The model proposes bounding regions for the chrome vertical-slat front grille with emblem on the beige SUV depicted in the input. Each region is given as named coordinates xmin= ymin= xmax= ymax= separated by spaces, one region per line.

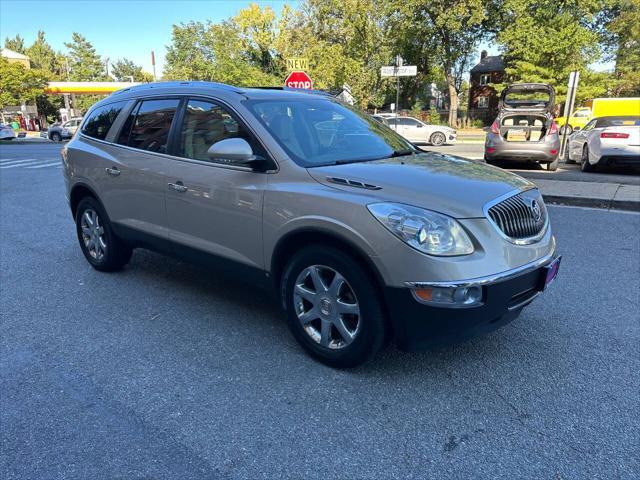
xmin=487 ymin=189 xmax=547 ymax=243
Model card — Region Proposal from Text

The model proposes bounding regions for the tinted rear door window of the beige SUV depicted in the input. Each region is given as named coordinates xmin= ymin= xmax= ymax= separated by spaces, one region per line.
xmin=123 ymin=98 xmax=180 ymax=153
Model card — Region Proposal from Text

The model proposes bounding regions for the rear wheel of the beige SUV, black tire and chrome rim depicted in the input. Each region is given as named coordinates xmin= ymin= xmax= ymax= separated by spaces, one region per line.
xmin=76 ymin=197 xmax=133 ymax=272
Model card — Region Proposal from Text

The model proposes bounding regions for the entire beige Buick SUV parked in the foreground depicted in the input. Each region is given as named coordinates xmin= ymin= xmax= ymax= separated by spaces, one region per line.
xmin=62 ymin=82 xmax=559 ymax=367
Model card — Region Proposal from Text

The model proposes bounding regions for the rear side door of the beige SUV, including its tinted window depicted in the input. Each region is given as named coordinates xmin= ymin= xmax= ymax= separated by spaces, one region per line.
xmin=100 ymin=97 xmax=181 ymax=240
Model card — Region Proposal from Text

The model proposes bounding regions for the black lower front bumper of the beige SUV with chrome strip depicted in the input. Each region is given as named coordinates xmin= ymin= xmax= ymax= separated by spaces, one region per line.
xmin=385 ymin=255 xmax=555 ymax=351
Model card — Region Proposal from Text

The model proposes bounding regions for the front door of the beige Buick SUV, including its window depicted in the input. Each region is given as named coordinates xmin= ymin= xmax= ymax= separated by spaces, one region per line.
xmin=166 ymin=99 xmax=268 ymax=269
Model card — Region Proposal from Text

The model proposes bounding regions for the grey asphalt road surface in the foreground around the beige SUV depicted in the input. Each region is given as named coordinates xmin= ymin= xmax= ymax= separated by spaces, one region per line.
xmin=0 ymin=146 xmax=640 ymax=480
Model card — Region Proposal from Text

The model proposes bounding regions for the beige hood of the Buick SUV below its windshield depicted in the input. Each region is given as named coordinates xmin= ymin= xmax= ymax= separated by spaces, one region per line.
xmin=308 ymin=153 xmax=534 ymax=218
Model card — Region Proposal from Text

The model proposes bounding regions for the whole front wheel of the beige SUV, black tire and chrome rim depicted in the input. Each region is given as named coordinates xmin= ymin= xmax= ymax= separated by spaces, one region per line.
xmin=280 ymin=246 xmax=386 ymax=368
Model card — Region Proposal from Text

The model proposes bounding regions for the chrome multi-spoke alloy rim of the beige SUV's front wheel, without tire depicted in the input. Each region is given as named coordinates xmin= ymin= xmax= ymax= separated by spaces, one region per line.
xmin=293 ymin=265 xmax=360 ymax=349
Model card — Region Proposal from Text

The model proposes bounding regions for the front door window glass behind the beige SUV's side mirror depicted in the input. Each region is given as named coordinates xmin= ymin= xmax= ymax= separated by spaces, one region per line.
xmin=178 ymin=99 xmax=261 ymax=161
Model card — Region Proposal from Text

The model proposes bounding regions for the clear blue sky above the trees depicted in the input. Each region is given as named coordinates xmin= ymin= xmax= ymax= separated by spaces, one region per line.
xmin=0 ymin=0 xmax=612 ymax=77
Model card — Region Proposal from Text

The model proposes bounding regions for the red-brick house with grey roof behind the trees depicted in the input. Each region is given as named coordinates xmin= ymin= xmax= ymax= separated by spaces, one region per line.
xmin=469 ymin=50 xmax=505 ymax=125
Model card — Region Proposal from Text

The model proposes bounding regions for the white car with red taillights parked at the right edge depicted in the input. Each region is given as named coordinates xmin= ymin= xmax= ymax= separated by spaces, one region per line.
xmin=565 ymin=116 xmax=640 ymax=172
